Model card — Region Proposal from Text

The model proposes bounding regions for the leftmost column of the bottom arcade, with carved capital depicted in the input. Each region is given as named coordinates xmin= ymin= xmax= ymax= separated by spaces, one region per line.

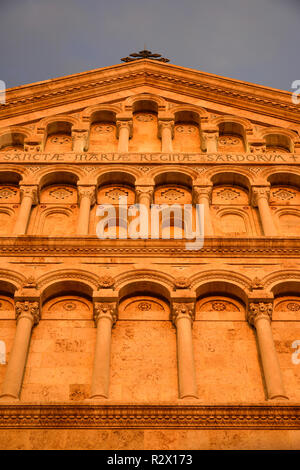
xmin=0 ymin=300 xmax=40 ymax=399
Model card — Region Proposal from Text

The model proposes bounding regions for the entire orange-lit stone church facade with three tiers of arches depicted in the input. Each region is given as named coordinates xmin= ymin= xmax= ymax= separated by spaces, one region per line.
xmin=0 ymin=59 xmax=300 ymax=449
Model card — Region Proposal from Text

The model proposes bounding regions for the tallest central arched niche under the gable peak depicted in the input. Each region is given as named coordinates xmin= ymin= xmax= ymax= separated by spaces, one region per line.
xmin=129 ymin=100 xmax=161 ymax=152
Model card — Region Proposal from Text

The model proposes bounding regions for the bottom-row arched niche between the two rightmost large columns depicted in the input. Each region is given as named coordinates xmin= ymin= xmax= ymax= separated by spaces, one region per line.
xmin=193 ymin=279 xmax=265 ymax=403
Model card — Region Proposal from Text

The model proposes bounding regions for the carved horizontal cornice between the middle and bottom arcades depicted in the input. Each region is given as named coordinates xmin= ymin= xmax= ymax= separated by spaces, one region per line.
xmin=0 ymin=235 xmax=300 ymax=258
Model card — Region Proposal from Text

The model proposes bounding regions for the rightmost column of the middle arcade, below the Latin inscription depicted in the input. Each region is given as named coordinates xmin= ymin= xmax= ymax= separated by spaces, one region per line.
xmin=252 ymin=186 xmax=277 ymax=237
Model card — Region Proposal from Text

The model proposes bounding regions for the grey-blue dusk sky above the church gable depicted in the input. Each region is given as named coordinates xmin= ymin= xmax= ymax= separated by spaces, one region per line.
xmin=0 ymin=0 xmax=300 ymax=91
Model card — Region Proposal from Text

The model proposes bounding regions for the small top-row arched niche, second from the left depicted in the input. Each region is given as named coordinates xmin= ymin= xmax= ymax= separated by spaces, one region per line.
xmin=45 ymin=121 xmax=72 ymax=152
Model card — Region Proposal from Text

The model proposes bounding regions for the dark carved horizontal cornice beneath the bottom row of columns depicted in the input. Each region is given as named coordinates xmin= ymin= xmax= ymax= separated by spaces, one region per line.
xmin=0 ymin=403 xmax=300 ymax=429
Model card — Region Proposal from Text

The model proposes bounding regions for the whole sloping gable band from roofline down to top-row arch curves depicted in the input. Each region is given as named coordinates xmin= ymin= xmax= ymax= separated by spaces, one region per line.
xmin=0 ymin=59 xmax=300 ymax=131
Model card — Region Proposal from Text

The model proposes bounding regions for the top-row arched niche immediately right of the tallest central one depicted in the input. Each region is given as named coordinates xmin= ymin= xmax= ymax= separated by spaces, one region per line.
xmin=173 ymin=111 xmax=201 ymax=152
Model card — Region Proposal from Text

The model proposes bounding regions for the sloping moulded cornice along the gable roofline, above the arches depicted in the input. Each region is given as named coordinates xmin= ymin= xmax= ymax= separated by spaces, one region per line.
xmin=0 ymin=60 xmax=300 ymax=123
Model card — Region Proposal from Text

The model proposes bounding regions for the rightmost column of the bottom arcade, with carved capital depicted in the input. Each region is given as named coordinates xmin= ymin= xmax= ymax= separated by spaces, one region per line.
xmin=248 ymin=302 xmax=287 ymax=400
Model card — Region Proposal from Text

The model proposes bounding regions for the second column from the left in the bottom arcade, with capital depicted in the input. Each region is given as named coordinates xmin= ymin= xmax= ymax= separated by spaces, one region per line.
xmin=90 ymin=302 xmax=117 ymax=398
